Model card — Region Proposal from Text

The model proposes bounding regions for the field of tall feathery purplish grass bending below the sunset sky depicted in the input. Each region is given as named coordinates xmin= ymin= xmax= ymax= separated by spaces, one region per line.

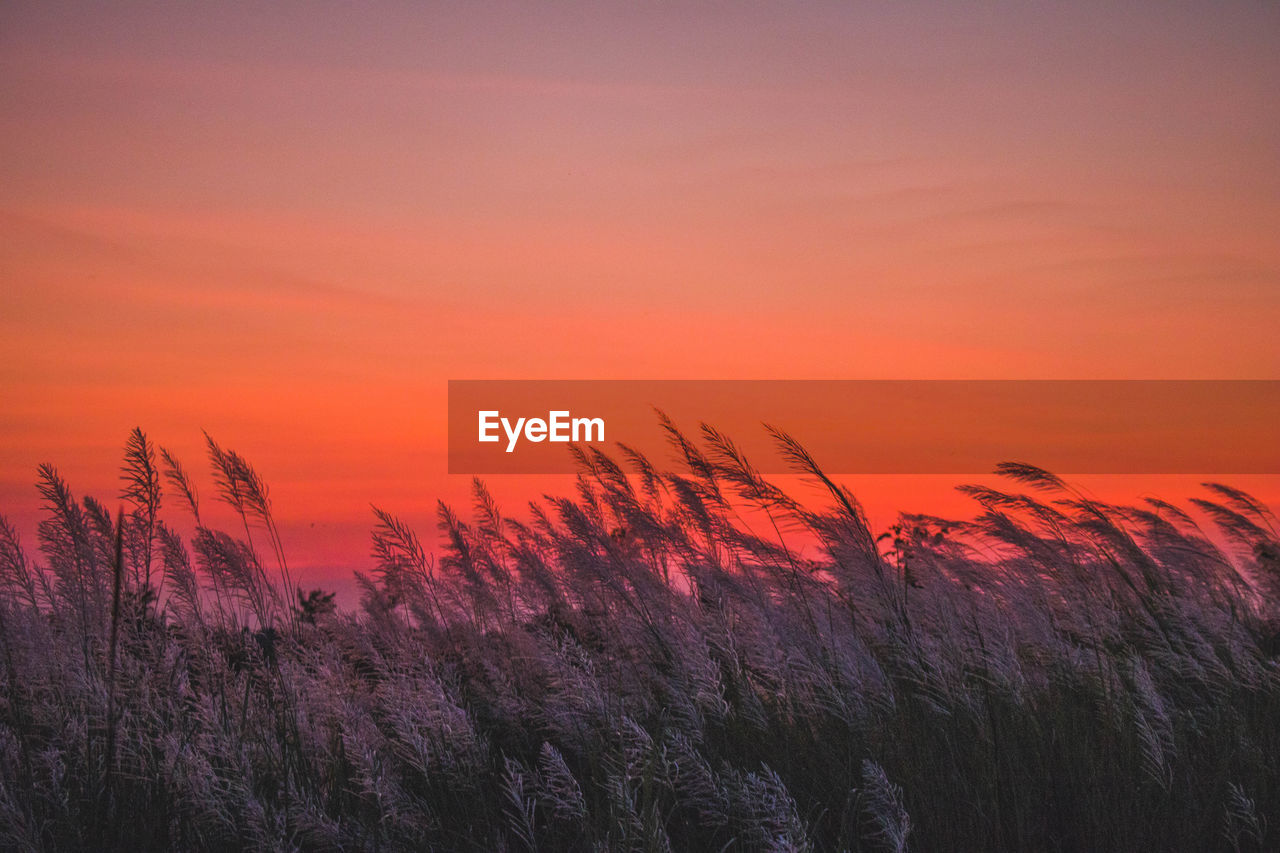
xmin=0 ymin=420 xmax=1280 ymax=852
